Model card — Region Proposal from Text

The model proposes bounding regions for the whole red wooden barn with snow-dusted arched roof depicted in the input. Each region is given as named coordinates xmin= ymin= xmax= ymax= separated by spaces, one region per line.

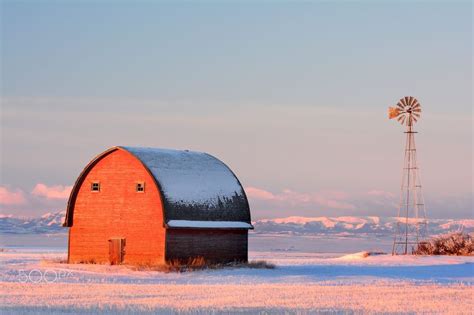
xmin=65 ymin=147 xmax=253 ymax=264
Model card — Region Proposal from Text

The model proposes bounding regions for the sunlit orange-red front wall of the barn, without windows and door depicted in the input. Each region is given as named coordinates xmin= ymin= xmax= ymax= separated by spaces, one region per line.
xmin=69 ymin=150 xmax=165 ymax=264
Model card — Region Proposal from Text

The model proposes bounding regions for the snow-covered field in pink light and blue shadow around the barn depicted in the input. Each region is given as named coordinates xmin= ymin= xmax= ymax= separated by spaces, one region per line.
xmin=0 ymin=244 xmax=474 ymax=314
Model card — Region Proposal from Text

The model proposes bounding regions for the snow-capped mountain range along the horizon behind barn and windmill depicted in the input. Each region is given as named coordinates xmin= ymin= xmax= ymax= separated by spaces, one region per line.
xmin=0 ymin=211 xmax=474 ymax=236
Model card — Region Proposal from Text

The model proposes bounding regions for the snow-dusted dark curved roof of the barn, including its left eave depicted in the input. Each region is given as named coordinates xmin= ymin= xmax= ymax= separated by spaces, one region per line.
xmin=65 ymin=146 xmax=252 ymax=228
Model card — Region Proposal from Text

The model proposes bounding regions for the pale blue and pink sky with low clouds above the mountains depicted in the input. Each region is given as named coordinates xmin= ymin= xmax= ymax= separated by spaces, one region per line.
xmin=0 ymin=0 xmax=473 ymax=219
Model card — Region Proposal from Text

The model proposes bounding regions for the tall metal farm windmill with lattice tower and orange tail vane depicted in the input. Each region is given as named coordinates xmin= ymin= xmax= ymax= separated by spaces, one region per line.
xmin=388 ymin=96 xmax=427 ymax=255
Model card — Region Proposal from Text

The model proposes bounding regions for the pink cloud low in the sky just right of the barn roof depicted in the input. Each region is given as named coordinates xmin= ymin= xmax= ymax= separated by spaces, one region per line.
xmin=245 ymin=187 xmax=355 ymax=210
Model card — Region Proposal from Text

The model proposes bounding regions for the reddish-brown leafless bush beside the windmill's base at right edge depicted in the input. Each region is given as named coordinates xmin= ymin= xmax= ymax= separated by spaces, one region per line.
xmin=414 ymin=232 xmax=474 ymax=256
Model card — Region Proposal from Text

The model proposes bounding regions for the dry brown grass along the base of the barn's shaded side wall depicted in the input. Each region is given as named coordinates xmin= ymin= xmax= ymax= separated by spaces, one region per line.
xmin=129 ymin=257 xmax=276 ymax=272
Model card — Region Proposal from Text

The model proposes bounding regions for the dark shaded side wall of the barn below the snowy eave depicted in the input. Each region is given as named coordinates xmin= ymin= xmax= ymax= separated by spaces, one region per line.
xmin=166 ymin=229 xmax=248 ymax=262
